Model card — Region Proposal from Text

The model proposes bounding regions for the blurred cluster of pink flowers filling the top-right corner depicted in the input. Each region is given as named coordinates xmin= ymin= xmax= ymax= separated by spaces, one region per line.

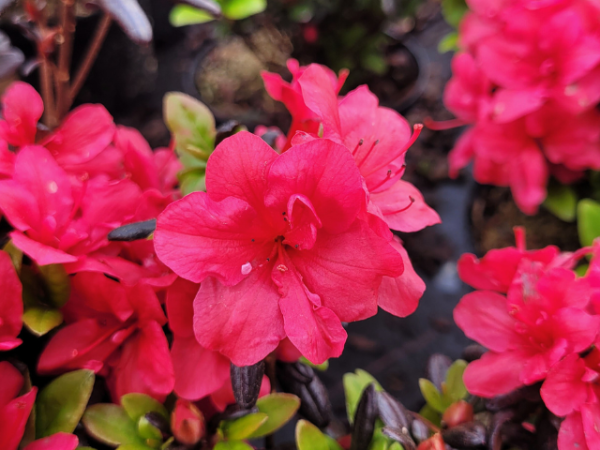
xmin=444 ymin=0 xmax=600 ymax=214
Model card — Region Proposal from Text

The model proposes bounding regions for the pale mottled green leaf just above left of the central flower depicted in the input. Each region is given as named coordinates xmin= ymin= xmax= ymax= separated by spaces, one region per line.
xmin=163 ymin=92 xmax=217 ymax=160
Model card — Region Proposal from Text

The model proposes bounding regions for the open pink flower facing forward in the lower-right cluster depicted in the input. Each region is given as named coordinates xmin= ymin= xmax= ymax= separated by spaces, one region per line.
xmin=454 ymin=259 xmax=600 ymax=397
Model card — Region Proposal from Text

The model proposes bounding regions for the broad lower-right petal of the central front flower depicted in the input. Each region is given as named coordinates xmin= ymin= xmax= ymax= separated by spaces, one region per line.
xmin=289 ymin=220 xmax=404 ymax=322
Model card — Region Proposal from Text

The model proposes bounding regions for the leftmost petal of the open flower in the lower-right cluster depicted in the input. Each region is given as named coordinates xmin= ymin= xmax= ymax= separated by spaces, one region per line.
xmin=454 ymin=291 xmax=522 ymax=352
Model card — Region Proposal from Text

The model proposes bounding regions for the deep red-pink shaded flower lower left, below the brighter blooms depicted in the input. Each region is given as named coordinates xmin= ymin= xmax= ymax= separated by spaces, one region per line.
xmin=38 ymin=272 xmax=174 ymax=402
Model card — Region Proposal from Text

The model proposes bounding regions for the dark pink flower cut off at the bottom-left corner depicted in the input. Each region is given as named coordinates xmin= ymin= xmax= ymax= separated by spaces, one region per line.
xmin=0 ymin=361 xmax=37 ymax=450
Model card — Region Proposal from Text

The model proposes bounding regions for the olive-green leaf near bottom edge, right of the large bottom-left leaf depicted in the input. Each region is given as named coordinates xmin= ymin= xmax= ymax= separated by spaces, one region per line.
xmin=83 ymin=403 xmax=145 ymax=447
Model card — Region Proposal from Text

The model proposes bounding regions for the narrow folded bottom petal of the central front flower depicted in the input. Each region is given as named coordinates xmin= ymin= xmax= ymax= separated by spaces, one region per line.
xmin=272 ymin=254 xmax=347 ymax=364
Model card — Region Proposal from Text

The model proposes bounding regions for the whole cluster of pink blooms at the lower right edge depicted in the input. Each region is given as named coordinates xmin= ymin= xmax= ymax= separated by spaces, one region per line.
xmin=454 ymin=229 xmax=600 ymax=450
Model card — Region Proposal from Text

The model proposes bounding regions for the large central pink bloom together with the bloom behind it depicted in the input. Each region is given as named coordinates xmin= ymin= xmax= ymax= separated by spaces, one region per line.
xmin=154 ymin=61 xmax=439 ymax=372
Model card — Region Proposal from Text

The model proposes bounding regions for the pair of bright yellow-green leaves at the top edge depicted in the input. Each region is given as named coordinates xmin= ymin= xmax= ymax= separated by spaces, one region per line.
xmin=169 ymin=0 xmax=267 ymax=27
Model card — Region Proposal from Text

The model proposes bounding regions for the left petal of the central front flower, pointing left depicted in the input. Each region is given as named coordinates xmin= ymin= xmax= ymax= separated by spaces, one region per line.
xmin=154 ymin=192 xmax=274 ymax=285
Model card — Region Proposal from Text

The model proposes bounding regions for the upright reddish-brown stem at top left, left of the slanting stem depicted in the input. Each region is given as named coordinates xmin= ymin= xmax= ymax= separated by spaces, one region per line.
xmin=56 ymin=0 xmax=76 ymax=121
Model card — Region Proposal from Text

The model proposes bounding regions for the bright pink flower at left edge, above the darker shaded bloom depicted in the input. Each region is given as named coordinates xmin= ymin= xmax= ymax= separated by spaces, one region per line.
xmin=0 ymin=146 xmax=141 ymax=265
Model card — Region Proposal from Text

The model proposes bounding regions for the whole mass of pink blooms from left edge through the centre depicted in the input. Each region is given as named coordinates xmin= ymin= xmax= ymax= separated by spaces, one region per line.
xmin=0 ymin=58 xmax=439 ymax=449
